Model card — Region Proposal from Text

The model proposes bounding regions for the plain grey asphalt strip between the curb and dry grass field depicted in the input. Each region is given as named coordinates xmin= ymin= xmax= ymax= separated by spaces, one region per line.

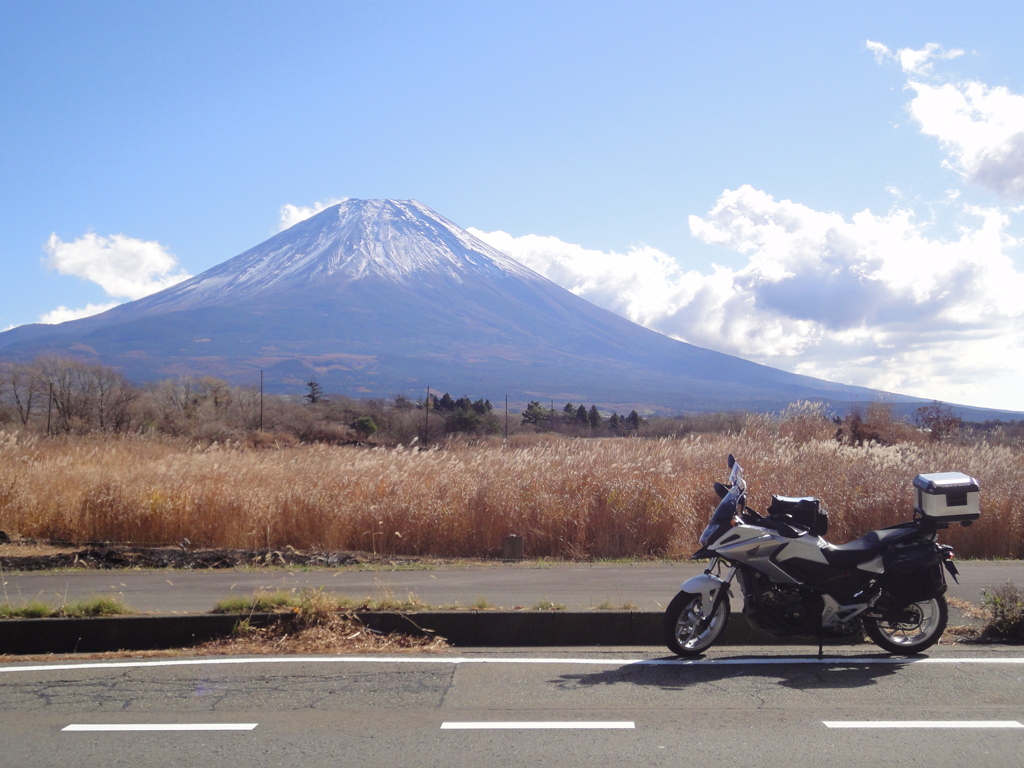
xmin=2 ymin=561 xmax=1024 ymax=613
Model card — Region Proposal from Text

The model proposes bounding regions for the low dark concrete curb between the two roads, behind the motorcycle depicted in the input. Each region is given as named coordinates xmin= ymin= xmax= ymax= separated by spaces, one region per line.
xmin=0 ymin=610 xmax=831 ymax=655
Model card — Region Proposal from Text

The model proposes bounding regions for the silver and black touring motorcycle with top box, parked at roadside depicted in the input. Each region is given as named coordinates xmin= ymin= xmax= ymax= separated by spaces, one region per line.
xmin=663 ymin=455 xmax=979 ymax=656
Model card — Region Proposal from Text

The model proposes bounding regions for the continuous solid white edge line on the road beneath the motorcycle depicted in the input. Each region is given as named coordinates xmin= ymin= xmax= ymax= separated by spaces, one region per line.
xmin=0 ymin=655 xmax=1024 ymax=673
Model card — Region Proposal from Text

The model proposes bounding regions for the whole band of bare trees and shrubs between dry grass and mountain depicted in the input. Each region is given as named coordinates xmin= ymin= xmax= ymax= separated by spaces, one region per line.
xmin=0 ymin=357 xmax=1011 ymax=445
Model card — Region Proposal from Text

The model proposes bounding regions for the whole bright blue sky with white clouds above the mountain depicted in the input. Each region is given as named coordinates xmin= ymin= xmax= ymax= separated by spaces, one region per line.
xmin=0 ymin=0 xmax=1024 ymax=410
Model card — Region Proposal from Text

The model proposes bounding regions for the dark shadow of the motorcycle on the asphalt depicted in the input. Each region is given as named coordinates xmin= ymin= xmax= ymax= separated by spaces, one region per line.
xmin=550 ymin=653 xmax=914 ymax=691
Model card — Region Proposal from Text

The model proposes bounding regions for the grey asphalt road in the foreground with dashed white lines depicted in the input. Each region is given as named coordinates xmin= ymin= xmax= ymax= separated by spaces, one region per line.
xmin=0 ymin=646 xmax=1024 ymax=768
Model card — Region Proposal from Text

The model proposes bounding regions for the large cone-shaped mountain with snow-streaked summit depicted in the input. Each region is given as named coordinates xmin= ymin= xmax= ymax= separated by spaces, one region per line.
xmin=0 ymin=200 xmax=954 ymax=413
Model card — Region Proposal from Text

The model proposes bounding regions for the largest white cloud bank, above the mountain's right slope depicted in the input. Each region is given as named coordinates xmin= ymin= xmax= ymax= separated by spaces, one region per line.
xmin=473 ymin=186 xmax=1024 ymax=409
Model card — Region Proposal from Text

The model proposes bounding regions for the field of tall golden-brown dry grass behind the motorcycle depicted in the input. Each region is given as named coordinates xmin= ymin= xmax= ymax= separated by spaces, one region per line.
xmin=0 ymin=415 xmax=1024 ymax=559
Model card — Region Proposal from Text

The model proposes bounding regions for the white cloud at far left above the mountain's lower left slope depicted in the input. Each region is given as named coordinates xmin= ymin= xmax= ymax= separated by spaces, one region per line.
xmin=40 ymin=232 xmax=191 ymax=323
